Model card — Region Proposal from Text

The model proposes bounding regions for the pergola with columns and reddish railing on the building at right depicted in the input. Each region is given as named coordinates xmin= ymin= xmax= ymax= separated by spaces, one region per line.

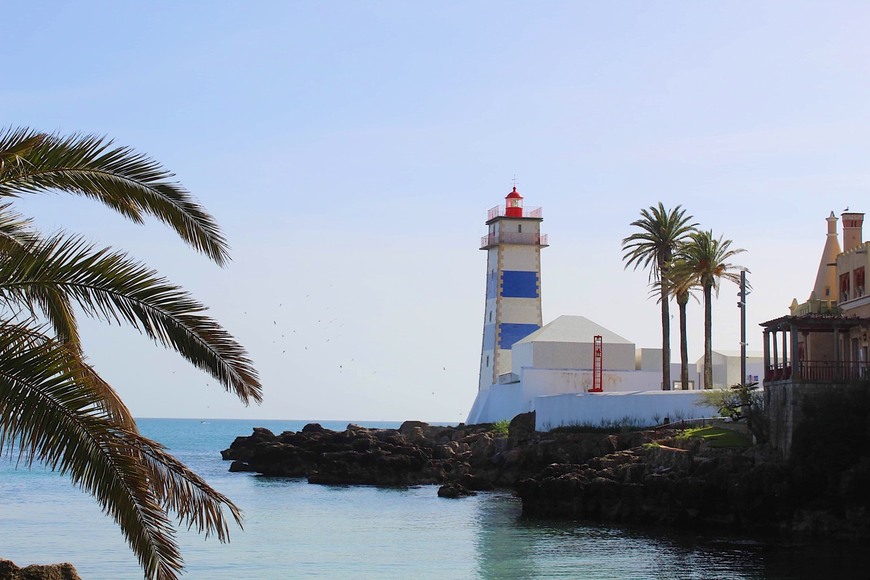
xmin=761 ymin=314 xmax=870 ymax=382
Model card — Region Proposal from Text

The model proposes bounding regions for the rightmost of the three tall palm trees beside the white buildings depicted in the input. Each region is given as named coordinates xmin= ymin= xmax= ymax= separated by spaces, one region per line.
xmin=672 ymin=230 xmax=746 ymax=389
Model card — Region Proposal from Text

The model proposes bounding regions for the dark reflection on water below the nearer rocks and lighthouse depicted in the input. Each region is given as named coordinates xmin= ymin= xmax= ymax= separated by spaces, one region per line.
xmin=475 ymin=494 xmax=866 ymax=580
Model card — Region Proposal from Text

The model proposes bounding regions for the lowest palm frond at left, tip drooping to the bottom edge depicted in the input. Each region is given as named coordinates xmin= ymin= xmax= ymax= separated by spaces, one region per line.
xmin=0 ymin=327 xmax=181 ymax=577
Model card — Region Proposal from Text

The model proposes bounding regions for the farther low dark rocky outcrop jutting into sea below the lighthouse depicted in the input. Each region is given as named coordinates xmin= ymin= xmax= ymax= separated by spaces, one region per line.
xmin=221 ymin=416 xmax=648 ymax=491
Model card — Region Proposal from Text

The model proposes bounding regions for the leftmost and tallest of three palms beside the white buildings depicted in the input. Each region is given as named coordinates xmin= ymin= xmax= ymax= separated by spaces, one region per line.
xmin=622 ymin=202 xmax=698 ymax=390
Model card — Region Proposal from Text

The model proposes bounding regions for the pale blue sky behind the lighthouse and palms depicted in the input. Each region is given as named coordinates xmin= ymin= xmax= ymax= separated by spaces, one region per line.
xmin=0 ymin=0 xmax=870 ymax=422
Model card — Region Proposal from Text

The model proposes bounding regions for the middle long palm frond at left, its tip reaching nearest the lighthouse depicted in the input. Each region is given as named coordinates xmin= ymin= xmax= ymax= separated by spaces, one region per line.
xmin=0 ymin=234 xmax=262 ymax=404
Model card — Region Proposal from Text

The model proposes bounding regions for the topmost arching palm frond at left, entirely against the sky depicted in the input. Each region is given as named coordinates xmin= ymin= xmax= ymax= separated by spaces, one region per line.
xmin=0 ymin=129 xmax=229 ymax=265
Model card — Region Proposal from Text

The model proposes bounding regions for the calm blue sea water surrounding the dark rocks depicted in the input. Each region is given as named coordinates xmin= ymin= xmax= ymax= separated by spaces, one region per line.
xmin=0 ymin=419 xmax=867 ymax=580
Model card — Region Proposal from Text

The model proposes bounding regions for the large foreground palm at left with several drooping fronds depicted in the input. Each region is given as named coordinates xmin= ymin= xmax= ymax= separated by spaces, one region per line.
xmin=0 ymin=129 xmax=262 ymax=579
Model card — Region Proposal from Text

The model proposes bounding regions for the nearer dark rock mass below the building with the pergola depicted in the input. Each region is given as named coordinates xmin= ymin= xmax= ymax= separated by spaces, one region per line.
xmin=516 ymin=428 xmax=870 ymax=541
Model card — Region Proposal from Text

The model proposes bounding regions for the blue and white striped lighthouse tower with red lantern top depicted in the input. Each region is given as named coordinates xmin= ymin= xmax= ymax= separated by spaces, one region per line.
xmin=478 ymin=186 xmax=547 ymax=390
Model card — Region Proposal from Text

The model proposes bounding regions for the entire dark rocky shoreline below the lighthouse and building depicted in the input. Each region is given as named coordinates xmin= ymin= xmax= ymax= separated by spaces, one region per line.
xmin=222 ymin=414 xmax=870 ymax=540
